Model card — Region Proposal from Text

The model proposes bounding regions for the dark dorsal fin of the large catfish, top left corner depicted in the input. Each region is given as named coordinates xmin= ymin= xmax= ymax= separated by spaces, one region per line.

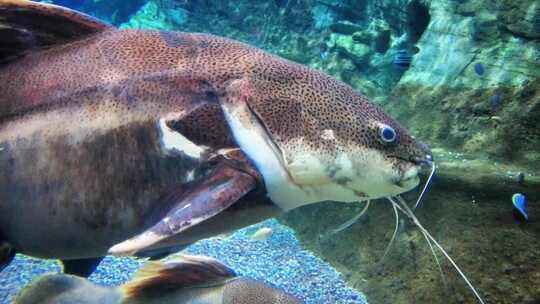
xmin=0 ymin=0 xmax=113 ymax=64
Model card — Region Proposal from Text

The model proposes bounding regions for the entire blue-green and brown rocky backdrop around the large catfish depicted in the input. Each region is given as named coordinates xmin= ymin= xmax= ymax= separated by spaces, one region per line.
xmin=42 ymin=0 xmax=540 ymax=303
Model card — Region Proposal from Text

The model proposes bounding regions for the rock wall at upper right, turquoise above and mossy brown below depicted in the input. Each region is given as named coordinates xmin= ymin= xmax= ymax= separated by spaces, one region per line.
xmin=383 ymin=0 xmax=540 ymax=168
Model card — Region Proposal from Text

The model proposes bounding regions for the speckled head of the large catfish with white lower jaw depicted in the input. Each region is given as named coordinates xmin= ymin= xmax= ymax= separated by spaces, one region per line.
xmin=221 ymin=56 xmax=431 ymax=209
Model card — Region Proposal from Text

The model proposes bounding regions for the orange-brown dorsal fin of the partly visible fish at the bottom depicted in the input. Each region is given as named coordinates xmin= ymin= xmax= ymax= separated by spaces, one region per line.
xmin=120 ymin=255 xmax=236 ymax=299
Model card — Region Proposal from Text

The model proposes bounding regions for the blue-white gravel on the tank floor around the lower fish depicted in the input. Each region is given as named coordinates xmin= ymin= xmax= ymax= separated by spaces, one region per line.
xmin=0 ymin=220 xmax=367 ymax=304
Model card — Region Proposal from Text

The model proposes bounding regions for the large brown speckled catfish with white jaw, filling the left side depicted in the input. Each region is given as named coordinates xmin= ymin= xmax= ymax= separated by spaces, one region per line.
xmin=0 ymin=0 xmax=431 ymax=275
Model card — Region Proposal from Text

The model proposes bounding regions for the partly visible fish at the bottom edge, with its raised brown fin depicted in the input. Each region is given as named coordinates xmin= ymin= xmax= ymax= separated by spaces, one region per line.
xmin=14 ymin=256 xmax=303 ymax=304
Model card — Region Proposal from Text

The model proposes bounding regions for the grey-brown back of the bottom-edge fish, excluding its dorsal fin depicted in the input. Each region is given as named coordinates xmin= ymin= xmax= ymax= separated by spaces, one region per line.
xmin=14 ymin=274 xmax=303 ymax=304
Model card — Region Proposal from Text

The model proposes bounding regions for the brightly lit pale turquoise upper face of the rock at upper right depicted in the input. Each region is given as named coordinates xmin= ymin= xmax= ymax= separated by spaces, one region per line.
xmin=402 ymin=1 xmax=540 ymax=89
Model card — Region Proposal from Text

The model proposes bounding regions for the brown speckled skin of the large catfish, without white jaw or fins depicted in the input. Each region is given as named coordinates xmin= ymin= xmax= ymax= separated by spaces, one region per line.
xmin=0 ymin=30 xmax=429 ymax=258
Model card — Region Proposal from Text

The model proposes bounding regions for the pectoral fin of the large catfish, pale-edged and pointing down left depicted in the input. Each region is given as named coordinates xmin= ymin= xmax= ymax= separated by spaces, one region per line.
xmin=109 ymin=163 xmax=257 ymax=255
